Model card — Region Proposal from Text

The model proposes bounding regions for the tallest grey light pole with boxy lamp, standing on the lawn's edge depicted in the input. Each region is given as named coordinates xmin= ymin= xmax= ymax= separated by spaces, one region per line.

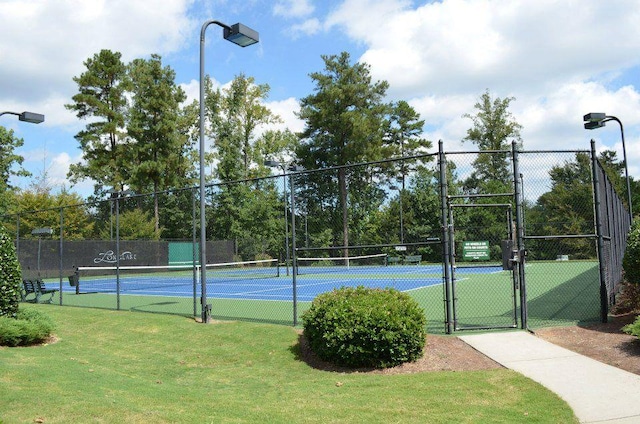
xmin=200 ymin=20 xmax=259 ymax=323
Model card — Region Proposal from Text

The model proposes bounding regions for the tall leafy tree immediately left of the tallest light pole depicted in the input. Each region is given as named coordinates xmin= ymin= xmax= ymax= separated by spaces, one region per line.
xmin=124 ymin=55 xmax=193 ymax=231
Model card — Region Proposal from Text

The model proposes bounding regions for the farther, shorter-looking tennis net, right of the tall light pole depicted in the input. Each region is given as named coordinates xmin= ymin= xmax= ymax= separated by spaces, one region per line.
xmin=296 ymin=253 xmax=388 ymax=275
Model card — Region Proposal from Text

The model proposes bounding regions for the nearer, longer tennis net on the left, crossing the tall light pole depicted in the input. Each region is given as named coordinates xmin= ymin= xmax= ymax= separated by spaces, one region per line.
xmin=75 ymin=259 xmax=280 ymax=295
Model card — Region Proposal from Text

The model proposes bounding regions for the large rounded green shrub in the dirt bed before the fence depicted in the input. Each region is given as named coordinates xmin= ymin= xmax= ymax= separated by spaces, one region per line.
xmin=302 ymin=287 xmax=426 ymax=368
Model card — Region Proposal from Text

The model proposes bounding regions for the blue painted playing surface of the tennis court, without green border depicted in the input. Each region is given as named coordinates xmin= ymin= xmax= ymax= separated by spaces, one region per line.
xmin=64 ymin=265 xmax=502 ymax=301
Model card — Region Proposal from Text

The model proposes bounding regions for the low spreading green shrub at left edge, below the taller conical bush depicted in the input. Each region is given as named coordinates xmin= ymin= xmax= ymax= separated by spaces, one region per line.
xmin=0 ymin=309 xmax=55 ymax=346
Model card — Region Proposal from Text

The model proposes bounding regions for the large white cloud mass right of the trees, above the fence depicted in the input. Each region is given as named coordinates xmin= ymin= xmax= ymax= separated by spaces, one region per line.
xmin=325 ymin=0 xmax=640 ymax=175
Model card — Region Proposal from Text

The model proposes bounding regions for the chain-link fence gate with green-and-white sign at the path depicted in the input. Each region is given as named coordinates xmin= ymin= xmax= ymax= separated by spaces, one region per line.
xmin=448 ymin=202 xmax=520 ymax=330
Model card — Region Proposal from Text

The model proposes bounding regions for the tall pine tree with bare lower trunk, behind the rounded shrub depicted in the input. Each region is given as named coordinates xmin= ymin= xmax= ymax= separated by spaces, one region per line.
xmin=297 ymin=52 xmax=389 ymax=252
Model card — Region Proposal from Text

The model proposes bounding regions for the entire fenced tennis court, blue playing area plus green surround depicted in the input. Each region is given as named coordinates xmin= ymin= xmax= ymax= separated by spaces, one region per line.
xmin=40 ymin=255 xmax=599 ymax=333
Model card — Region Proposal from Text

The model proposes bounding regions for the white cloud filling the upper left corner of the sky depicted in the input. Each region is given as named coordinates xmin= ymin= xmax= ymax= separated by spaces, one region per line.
xmin=0 ymin=0 xmax=193 ymax=104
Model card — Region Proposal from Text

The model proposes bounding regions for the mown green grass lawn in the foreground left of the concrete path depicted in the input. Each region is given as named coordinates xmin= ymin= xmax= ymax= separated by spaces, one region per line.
xmin=0 ymin=304 xmax=577 ymax=424
